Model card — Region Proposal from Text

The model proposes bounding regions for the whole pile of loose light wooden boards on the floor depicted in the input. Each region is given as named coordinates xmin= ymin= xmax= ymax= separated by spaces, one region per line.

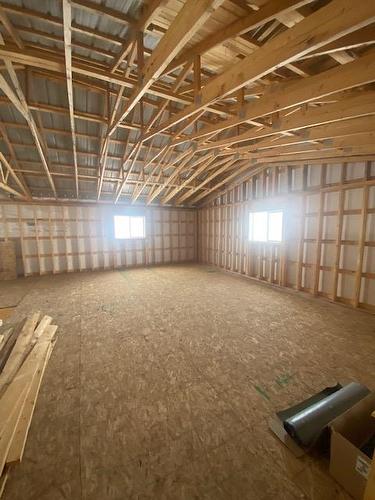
xmin=0 ymin=312 xmax=57 ymax=497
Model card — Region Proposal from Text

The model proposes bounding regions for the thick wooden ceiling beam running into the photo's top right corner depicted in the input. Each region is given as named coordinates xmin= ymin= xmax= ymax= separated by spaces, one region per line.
xmin=146 ymin=0 xmax=375 ymax=139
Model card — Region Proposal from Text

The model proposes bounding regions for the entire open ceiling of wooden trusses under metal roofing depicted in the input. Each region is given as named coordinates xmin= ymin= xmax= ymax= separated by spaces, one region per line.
xmin=0 ymin=0 xmax=375 ymax=206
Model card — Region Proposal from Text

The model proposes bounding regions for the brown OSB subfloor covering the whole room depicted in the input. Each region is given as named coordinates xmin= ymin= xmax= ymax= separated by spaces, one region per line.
xmin=0 ymin=265 xmax=375 ymax=500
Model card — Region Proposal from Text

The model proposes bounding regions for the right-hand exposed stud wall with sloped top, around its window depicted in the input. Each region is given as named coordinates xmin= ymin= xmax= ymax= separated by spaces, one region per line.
xmin=198 ymin=162 xmax=375 ymax=312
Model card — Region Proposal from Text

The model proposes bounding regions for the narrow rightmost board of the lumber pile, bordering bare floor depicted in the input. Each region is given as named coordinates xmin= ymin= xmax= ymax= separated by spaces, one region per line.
xmin=6 ymin=336 xmax=57 ymax=464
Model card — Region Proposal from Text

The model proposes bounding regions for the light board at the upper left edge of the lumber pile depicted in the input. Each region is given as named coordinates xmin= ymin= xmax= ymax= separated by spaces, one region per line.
xmin=0 ymin=311 xmax=40 ymax=394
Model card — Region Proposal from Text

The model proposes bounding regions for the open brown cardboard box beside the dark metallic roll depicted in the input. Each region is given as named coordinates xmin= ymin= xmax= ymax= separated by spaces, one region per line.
xmin=329 ymin=393 xmax=375 ymax=500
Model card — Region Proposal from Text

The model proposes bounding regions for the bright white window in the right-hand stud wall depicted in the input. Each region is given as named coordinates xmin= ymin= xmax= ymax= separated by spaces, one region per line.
xmin=249 ymin=211 xmax=283 ymax=241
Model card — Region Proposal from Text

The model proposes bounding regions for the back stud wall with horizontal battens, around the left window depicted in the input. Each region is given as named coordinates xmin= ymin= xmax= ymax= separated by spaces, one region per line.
xmin=0 ymin=203 xmax=196 ymax=276
